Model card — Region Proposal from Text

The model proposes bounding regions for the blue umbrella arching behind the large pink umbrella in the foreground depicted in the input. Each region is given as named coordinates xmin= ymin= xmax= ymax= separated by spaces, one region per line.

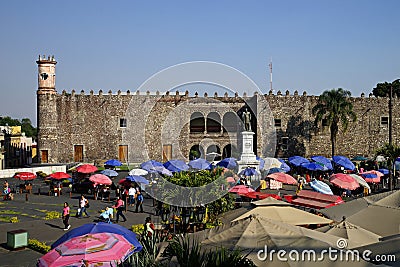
xmin=51 ymin=222 xmax=143 ymax=252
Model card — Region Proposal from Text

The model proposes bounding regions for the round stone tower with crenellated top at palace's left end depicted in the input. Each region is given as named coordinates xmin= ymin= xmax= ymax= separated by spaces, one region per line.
xmin=36 ymin=55 xmax=58 ymax=163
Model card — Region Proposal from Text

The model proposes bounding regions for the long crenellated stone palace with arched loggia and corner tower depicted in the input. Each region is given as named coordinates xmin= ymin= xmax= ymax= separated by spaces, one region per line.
xmin=36 ymin=56 xmax=400 ymax=163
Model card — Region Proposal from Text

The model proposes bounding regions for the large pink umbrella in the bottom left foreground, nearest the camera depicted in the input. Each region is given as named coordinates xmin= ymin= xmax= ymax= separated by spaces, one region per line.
xmin=38 ymin=233 xmax=135 ymax=267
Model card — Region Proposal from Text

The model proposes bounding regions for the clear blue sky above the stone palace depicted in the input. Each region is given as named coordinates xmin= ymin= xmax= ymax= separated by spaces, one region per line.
xmin=0 ymin=0 xmax=400 ymax=124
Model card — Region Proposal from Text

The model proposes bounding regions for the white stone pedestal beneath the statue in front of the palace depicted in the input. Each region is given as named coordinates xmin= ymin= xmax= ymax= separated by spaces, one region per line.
xmin=238 ymin=132 xmax=260 ymax=178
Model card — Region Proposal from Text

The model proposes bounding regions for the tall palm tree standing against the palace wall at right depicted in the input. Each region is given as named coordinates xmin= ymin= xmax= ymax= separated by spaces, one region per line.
xmin=312 ymin=88 xmax=357 ymax=157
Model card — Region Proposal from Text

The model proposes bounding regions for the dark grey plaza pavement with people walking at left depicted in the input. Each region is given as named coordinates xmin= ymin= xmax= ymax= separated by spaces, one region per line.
xmin=0 ymin=178 xmax=160 ymax=267
